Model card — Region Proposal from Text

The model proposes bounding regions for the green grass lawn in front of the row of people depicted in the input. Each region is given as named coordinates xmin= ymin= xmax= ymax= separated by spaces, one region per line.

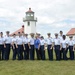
xmin=0 ymin=50 xmax=75 ymax=75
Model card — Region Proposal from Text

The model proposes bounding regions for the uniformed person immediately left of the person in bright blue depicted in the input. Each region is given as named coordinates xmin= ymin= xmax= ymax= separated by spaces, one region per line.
xmin=28 ymin=33 xmax=35 ymax=60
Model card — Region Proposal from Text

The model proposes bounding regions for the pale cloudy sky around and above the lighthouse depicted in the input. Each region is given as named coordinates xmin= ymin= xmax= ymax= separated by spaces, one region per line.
xmin=0 ymin=0 xmax=75 ymax=36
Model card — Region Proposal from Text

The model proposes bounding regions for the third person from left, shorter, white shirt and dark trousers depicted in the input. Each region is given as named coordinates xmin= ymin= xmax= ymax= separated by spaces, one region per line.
xmin=12 ymin=34 xmax=17 ymax=60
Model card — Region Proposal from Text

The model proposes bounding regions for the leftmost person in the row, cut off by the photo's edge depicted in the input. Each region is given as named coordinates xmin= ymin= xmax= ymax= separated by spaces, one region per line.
xmin=0 ymin=32 xmax=4 ymax=60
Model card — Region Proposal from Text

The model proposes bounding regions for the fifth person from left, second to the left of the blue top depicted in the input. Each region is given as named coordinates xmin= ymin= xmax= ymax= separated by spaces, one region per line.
xmin=23 ymin=34 xmax=29 ymax=60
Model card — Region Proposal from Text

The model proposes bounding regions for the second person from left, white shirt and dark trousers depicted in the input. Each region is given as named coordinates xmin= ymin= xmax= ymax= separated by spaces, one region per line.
xmin=4 ymin=31 xmax=11 ymax=60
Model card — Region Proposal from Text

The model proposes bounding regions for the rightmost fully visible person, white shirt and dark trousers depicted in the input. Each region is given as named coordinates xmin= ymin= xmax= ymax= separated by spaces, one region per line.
xmin=68 ymin=36 xmax=75 ymax=60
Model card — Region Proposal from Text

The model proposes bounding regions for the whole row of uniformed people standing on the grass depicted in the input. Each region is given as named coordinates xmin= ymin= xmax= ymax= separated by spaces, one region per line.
xmin=0 ymin=31 xmax=75 ymax=61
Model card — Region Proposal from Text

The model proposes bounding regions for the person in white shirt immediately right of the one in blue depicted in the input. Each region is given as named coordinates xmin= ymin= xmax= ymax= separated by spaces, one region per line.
xmin=40 ymin=36 xmax=45 ymax=60
